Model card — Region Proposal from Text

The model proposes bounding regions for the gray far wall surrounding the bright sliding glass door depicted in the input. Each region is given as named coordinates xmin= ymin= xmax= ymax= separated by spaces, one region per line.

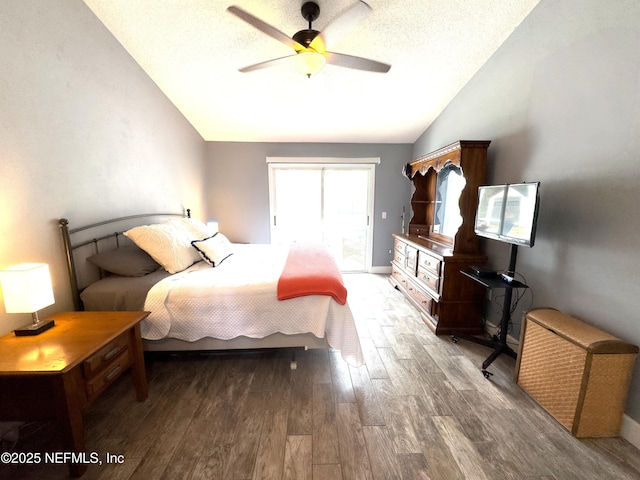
xmin=206 ymin=142 xmax=412 ymax=267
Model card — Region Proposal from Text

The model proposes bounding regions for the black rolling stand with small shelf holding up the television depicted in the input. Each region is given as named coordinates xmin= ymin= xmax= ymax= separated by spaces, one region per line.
xmin=451 ymin=244 xmax=529 ymax=378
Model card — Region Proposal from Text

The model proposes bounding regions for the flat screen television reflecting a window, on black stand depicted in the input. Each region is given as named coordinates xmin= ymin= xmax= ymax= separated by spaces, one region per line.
xmin=474 ymin=182 xmax=540 ymax=247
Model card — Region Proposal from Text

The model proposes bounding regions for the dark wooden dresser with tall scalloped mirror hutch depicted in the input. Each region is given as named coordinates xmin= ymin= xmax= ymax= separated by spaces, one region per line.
xmin=390 ymin=140 xmax=490 ymax=335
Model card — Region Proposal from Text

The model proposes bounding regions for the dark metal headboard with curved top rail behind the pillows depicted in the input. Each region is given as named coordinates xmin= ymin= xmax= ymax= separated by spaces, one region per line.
xmin=59 ymin=208 xmax=191 ymax=310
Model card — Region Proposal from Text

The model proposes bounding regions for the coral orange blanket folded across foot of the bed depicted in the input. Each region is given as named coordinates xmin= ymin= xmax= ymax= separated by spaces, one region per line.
xmin=278 ymin=242 xmax=347 ymax=305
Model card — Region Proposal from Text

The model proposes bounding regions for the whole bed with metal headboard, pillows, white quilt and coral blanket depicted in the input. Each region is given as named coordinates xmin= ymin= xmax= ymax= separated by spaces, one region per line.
xmin=59 ymin=210 xmax=363 ymax=368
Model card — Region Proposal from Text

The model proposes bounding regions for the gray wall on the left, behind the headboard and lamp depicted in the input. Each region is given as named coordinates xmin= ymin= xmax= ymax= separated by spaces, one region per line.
xmin=0 ymin=0 xmax=205 ymax=333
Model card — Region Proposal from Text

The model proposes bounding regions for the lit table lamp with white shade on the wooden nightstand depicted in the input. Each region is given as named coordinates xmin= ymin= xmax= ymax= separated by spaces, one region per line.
xmin=0 ymin=263 xmax=54 ymax=336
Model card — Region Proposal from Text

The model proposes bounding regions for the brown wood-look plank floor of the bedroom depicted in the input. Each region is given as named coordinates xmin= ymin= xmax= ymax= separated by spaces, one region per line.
xmin=0 ymin=275 xmax=640 ymax=480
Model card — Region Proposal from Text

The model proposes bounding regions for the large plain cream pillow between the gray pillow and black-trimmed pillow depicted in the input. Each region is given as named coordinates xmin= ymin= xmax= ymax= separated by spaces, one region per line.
xmin=124 ymin=223 xmax=200 ymax=273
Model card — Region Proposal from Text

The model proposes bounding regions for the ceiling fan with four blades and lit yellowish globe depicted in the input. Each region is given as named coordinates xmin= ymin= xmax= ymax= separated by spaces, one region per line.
xmin=227 ymin=1 xmax=391 ymax=77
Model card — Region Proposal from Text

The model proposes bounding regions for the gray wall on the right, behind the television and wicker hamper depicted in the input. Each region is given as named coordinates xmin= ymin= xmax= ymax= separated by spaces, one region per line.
xmin=414 ymin=0 xmax=640 ymax=421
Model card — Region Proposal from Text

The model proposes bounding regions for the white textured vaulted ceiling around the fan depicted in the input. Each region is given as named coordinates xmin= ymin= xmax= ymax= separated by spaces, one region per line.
xmin=84 ymin=0 xmax=539 ymax=143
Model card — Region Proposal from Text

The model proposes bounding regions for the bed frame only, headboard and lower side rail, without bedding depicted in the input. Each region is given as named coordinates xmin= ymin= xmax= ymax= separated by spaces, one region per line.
xmin=59 ymin=209 xmax=330 ymax=356
